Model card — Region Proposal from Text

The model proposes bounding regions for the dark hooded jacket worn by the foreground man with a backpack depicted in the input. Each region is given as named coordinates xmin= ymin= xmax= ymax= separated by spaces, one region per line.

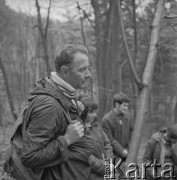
xmin=20 ymin=78 xmax=94 ymax=180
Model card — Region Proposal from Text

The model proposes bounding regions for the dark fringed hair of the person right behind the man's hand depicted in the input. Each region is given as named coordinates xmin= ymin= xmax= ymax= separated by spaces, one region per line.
xmin=80 ymin=97 xmax=98 ymax=122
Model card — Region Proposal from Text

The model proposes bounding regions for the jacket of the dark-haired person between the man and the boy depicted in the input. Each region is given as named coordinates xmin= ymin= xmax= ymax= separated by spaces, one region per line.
xmin=89 ymin=118 xmax=113 ymax=180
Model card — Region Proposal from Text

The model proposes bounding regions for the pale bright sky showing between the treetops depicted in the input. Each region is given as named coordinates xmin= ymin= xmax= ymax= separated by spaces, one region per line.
xmin=6 ymin=0 xmax=155 ymax=21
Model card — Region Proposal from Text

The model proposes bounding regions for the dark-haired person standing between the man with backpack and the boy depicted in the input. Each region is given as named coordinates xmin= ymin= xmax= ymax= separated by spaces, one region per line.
xmin=81 ymin=97 xmax=113 ymax=180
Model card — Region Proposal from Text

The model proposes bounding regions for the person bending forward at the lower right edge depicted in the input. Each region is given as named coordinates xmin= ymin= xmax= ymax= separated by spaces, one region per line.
xmin=143 ymin=124 xmax=177 ymax=180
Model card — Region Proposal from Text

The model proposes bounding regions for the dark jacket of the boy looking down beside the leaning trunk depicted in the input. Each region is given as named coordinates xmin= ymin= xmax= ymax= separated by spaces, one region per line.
xmin=102 ymin=110 xmax=133 ymax=157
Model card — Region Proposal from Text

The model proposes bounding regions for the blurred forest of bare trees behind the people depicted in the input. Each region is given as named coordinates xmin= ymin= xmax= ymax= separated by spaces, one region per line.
xmin=0 ymin=0 xmax=177 ymax=179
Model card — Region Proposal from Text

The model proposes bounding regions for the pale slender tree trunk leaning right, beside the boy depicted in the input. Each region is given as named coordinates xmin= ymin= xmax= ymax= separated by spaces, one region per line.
xmin=126 ymin=0 xmax=165 ymax=167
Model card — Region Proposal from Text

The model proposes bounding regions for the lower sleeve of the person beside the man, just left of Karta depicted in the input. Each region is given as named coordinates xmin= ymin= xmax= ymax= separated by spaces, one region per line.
xmin=89 ymin=154 xmax=104 ymax=175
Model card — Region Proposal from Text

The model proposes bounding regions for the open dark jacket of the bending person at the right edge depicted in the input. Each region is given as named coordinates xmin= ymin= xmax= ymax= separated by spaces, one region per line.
xmin=143 ymin=129 xmax=177 ymax=180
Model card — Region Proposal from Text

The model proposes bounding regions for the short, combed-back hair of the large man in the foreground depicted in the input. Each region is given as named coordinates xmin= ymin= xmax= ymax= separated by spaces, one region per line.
xmin=55 ymin=44 xmax=88 ymax=72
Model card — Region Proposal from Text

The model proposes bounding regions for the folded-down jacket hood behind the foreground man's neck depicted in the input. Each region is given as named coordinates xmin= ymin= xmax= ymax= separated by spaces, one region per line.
xmin=28 ymin=77 xmax=77 ymax=112
